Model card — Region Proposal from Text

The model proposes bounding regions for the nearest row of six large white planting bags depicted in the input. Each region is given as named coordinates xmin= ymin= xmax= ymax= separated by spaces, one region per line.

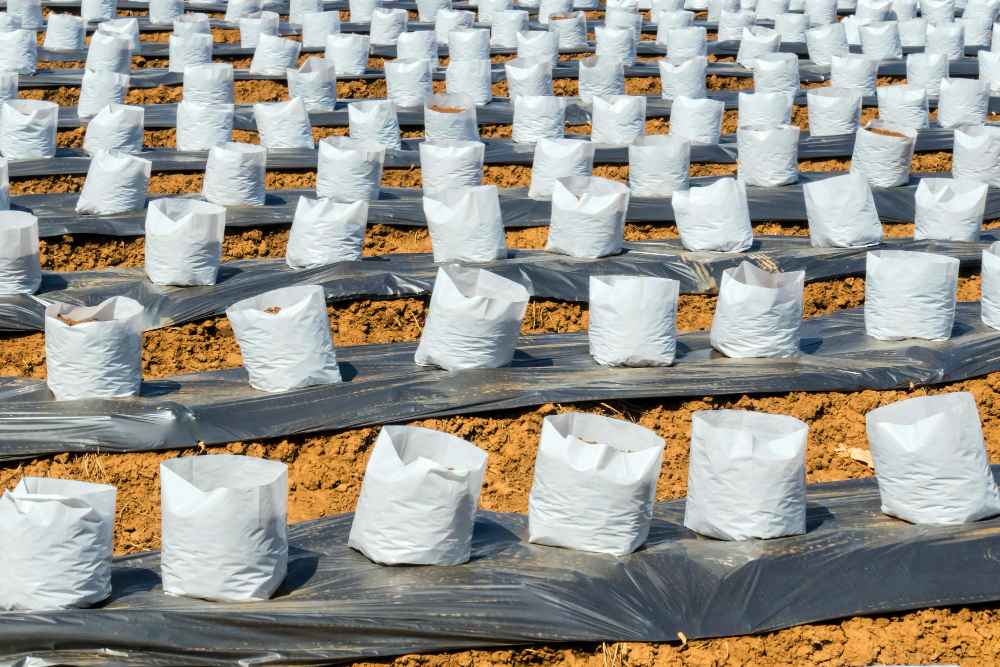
xmin=0 ymin=393 xmax=1000 ymax=611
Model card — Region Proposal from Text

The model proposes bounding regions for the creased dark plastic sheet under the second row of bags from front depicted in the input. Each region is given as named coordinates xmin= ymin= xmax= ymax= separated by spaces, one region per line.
xmin=0 ymin=302 xmax=1000 ymax=462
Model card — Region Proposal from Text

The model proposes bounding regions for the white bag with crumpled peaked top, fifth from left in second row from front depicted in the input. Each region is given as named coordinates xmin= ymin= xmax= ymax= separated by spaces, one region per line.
xmin=709 ymin=262 xmax=805 ymax=358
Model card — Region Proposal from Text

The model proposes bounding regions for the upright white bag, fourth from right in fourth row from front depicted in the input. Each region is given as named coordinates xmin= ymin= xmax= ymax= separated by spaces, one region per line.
xmin=628 ymin=134 xmax=691 ymax=197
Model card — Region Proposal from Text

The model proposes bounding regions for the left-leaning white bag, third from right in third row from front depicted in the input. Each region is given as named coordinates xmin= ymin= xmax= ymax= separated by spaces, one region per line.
xmin=672 ymin=178 xmax=753 ymax=252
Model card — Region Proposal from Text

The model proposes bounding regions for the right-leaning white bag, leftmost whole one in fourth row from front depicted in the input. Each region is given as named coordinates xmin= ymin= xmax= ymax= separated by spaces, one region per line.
xmin=76 ymin=151 xmax=153 ymax=215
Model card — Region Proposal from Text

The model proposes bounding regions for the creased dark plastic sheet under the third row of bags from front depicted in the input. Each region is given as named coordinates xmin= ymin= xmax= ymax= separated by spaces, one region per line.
xmin=0 ymin=233 xmax=1000 ymax=332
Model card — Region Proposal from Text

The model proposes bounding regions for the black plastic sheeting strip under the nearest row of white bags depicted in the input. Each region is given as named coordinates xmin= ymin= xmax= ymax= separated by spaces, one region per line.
xmin=0 ymin=468 xmax=1000 ymax=667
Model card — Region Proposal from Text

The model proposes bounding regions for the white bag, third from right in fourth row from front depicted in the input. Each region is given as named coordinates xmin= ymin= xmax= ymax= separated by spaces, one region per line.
xmin=736 ymin=125 xmax=799 ymax=188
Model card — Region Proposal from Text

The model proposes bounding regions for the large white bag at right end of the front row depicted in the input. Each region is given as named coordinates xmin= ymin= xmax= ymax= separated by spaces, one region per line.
xmin=865 ymin=392 xmax=1000 ymax=525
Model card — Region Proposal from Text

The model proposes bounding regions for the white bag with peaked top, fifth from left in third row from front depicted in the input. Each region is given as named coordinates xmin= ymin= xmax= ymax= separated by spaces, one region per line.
xmin=545 ymin=176 xmax=629 ymax=259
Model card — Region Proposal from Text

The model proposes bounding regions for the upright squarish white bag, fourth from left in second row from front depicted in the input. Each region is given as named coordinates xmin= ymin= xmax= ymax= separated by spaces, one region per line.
xmin=587 ymin=275 xmax=680 ymax=367
